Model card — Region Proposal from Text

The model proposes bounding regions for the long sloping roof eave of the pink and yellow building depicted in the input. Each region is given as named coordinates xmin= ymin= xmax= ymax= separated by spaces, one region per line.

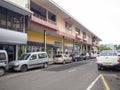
xmin=36 ymin=0 xmax=101 ymax=41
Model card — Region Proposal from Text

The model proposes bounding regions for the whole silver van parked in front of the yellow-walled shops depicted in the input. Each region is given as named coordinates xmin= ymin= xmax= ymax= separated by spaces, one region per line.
xmin=9 ymin=52 xmax=48 ymax=72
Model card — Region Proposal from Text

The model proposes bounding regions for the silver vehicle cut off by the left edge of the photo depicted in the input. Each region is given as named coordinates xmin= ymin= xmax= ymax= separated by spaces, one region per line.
xmin=0 ymin=50 xmax=8 ymax=76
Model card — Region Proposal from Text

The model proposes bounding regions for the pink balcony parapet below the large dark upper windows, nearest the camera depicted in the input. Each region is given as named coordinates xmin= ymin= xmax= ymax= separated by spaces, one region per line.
xmin=31 ymin=15 xmax=59 ymax=30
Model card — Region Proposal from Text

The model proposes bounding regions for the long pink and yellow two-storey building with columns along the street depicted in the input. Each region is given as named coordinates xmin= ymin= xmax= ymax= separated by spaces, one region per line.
xmin=27 ymin=0 xmax=100 ymax=58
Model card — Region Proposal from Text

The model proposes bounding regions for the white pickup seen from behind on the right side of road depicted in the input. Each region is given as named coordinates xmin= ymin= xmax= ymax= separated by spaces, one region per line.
xmin=96 ymin=50 xmax=120 ymax=70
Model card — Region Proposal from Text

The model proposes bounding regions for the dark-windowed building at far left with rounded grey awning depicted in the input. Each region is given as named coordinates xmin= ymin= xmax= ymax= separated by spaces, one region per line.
xmin=0 ymin=0 xmax=31 ymax=61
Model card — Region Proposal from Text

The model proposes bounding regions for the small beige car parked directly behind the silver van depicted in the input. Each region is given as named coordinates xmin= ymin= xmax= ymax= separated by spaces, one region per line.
xmin=54 ymin=54 xmax=72 ymax=64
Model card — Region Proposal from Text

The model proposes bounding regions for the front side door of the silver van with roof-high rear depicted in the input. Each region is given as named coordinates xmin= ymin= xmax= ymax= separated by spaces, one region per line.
xmin=29 ymin=54 xmax=38 ymax=68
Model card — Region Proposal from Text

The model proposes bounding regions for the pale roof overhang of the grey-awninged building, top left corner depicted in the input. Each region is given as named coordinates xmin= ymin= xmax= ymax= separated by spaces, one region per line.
xmin=0 ymin=0 xmax=32 ymax=15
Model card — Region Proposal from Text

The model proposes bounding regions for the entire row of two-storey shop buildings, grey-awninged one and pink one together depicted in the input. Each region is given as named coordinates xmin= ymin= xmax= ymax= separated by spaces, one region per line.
xmin=0 ymin=0 xmax=100 ymax=61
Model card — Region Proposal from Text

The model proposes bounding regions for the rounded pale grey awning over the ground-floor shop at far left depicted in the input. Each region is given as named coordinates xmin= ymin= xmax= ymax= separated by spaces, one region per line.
xmin=0 ymin=28 xmax=27 ymax=44
